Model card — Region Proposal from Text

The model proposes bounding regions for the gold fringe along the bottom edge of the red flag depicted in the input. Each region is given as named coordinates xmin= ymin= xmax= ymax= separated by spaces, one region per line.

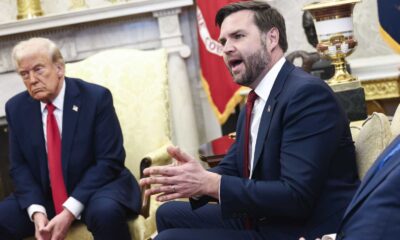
xmin=200 ymin=71 xmax=247 ymax=125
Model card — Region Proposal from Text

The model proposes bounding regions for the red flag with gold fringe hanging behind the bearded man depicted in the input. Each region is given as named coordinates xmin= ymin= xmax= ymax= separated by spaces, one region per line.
xmin=197 ymin=0 xmax=247 ymax=124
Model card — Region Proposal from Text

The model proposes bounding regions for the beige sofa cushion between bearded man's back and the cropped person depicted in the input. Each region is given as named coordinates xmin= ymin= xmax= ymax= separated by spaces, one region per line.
xmin=355 ymin=113 xmax=392 ymax=179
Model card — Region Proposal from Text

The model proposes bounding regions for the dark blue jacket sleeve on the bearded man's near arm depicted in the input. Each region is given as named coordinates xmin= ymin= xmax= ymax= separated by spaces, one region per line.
xmin=220 ymin=84 xmax=345 ymax=218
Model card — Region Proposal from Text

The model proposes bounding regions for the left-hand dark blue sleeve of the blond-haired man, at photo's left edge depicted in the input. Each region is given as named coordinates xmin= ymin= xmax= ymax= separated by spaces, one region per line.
xmin=6 ymin=103 xmax=45 ymax=209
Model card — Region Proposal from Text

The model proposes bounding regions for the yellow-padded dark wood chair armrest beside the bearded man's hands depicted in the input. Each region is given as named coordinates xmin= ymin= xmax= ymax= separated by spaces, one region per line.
xmin=140 ymin=142 xmax=172 ymax=218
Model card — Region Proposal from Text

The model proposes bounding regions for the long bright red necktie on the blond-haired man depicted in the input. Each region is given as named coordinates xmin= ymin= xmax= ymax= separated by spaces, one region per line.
xmin=46 ymin=103 xmax=68 ymax=214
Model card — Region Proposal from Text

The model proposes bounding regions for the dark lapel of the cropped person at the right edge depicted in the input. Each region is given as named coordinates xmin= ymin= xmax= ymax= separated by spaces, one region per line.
xmin=344 ymin=136 xmax=400 ymax=217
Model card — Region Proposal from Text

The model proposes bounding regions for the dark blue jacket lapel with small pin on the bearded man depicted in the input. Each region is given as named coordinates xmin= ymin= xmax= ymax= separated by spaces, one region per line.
xmin=252 ymin=61 xmax=295 ymax=171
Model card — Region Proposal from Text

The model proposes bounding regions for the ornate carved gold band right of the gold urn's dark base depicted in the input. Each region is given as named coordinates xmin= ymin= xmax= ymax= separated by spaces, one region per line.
xmin=361 ymin=77 xmax=400 ymax=101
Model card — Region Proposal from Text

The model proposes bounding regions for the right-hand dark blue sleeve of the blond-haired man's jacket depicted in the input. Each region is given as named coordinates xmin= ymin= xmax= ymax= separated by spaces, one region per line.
xmin=71 ymin=90 xmax=125 ymax=205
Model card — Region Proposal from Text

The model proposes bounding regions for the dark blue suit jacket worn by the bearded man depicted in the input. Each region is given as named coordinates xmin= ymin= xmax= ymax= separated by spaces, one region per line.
xmin=192 ymin=61 xmax=359 ymax=240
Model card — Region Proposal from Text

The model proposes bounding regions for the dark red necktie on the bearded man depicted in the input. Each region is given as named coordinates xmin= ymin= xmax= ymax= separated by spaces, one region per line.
xmin=243 ymin=90 xmax=258 ymax=178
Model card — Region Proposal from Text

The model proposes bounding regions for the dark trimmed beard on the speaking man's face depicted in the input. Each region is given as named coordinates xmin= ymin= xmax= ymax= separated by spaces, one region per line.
xmin=229 ymin=39 xmax=271 ymax=87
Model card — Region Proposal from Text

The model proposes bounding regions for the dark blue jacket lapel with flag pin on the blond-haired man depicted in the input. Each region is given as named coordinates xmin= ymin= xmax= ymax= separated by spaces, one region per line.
xmin=61 ymin=77 xmax=81 ymax=186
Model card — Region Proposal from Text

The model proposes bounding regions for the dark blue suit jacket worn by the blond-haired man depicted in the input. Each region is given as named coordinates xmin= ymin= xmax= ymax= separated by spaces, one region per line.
xmin=6 ymin=78 xmax=141 ymax=216
